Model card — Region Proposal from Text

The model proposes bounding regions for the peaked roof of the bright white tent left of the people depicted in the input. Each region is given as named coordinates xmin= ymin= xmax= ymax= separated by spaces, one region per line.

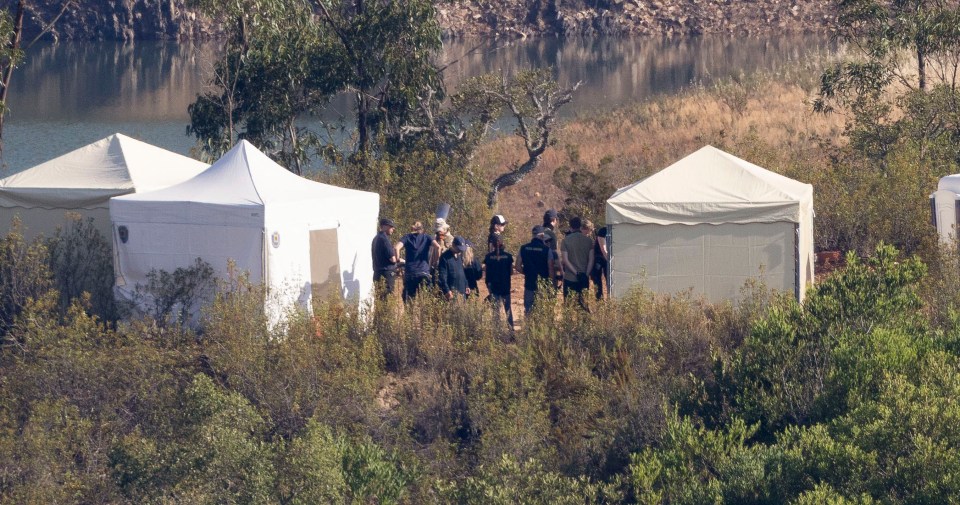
xmin=120 ymin=140 xmax=376 ymax=205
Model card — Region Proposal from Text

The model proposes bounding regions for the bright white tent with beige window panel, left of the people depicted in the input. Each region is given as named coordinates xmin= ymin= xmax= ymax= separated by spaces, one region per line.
xmin=110 ymin=140 xmax=380 ymax=322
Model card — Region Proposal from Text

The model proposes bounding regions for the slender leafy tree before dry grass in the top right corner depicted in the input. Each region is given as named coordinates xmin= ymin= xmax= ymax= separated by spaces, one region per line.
xmin=814 ymin=0 xmax=960 ymax=165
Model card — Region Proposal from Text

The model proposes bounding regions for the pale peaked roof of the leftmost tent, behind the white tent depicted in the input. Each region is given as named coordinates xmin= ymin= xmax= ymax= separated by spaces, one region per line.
xmin=0 ymin=133 xmax=207 ymax=207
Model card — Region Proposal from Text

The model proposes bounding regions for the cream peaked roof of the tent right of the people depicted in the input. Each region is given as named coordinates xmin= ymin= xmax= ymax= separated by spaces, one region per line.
xmin=607 ymin=145 xmax=813 ymax=224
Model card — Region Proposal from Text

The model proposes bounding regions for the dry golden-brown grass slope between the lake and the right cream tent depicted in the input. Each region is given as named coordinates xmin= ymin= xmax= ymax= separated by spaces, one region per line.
xmin=477 ymin=69 xmax=843 ymax=229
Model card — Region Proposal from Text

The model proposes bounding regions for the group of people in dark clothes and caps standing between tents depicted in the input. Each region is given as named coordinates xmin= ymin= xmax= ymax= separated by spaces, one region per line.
xmin=372 ymin=209 xmax=609 ymax=328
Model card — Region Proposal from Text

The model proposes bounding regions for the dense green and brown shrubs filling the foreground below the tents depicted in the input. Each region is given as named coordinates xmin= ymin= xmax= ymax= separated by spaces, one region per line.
xmin=0 ymin=211 xmax=960 ymax=504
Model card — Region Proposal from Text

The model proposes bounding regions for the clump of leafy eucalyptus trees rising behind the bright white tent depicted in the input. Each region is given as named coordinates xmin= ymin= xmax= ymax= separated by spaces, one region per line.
xmin=187 ymin=0 xmax=442 ymax=172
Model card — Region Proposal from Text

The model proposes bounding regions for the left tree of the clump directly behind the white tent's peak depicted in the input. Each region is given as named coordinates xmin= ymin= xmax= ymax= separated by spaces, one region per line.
xmin=187 ymin=0 xmax=343 ymax=173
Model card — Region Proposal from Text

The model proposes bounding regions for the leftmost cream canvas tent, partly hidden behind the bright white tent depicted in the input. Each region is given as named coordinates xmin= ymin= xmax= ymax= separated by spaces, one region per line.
xmin=0 ymin=133 xmax=208 ymax=237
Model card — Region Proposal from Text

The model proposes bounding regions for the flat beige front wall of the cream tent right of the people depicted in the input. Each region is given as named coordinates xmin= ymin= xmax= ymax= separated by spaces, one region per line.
xmin=610 ymin=222 xmax=796 ymax=301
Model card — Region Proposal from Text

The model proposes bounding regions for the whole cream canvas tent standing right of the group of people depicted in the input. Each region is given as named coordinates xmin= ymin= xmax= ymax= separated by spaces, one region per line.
xmin=606 ymin=146 xmax=814 ymax=302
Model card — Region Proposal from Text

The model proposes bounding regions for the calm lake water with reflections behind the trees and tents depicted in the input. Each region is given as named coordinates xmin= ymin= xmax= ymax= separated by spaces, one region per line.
xmin=0 ymin=37 xmax=831 ymax=175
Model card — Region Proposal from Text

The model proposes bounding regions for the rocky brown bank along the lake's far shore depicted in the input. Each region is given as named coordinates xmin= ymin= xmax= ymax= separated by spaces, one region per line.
xmin=0 ymin=0 xmax=834 ymax=40
